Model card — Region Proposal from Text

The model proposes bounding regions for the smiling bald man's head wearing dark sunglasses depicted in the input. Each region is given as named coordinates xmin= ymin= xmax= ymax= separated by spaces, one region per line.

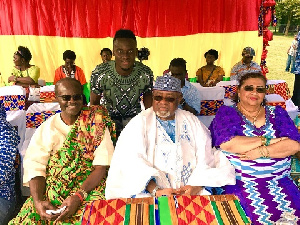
xmin=55 ymin=77 xmax=83 ymax=118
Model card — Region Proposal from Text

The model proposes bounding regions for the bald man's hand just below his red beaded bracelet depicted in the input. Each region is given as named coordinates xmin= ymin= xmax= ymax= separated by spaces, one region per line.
xmin=55 ymin=195 xmax=81 ymax=221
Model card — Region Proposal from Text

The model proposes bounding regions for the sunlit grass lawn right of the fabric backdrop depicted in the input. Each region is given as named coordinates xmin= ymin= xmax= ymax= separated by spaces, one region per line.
xmin=266 ymin=35 xmax=295 ymax=95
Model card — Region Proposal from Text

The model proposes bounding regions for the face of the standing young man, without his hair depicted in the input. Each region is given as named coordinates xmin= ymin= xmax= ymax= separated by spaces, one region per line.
xmin=113 ymin=38 xmax=137 ymax=75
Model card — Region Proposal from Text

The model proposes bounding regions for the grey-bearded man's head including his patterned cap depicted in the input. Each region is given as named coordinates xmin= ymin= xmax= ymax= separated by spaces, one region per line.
xmin=152 ymin=74 xmax=182 ymax=120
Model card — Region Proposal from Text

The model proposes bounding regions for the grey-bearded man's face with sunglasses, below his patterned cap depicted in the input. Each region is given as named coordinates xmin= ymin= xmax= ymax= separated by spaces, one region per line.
xmin=152 ymin=90 xmax=182 ymax=120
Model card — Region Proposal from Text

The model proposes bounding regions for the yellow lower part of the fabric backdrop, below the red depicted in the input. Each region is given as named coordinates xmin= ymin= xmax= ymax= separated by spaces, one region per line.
xmin=0 ymin=31 xmax=263 ymax=85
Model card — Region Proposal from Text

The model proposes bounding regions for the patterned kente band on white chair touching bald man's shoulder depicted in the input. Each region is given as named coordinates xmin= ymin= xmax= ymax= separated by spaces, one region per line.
xmin=26 ymin=110 xmax=61 ymax=128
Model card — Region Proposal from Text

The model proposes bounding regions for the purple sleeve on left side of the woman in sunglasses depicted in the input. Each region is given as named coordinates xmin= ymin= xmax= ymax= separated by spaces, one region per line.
xmin=209 ymin=106 xmax=245 ymax=147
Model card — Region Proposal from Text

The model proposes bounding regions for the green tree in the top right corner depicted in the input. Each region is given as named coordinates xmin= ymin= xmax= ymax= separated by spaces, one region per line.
xmin=276 ymin=0 xmax=300 ymax=36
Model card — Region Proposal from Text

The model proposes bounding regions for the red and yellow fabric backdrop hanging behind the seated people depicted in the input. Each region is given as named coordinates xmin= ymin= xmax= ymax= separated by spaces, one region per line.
xmin=0 ymin=0 xmax=263 ymax=82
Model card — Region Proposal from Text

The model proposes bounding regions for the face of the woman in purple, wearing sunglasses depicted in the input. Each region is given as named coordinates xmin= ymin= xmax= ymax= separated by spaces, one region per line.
xmin=238 ymin=78 xmax=266 ymax=107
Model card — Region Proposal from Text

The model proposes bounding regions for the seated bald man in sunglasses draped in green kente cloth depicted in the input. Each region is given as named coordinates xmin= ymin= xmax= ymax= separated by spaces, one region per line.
xmin=10 ymin=77 xmax=115 ymax=224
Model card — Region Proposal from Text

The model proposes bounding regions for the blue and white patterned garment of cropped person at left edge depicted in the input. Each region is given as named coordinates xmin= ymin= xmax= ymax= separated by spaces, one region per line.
xmin=0 ymin=104 xmax=20 ymax=201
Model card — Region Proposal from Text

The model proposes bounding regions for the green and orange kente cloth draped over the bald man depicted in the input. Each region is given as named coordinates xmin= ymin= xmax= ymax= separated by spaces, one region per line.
xmin=10 ymin=106 xmax=116 ymax=224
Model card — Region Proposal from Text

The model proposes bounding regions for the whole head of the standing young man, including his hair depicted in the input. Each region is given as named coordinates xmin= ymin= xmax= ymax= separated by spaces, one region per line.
xmin=113 ymin=29 xmax=137 ymax=75
